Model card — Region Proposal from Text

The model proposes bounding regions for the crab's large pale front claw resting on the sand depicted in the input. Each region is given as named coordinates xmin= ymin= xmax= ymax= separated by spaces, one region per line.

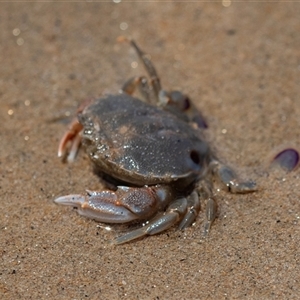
xmin=54 ymin=186 xmax=173 ymax=223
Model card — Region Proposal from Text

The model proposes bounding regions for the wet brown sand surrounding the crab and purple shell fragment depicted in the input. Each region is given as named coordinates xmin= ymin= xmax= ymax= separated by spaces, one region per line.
xmin=0 ymin=1 xmax=300 ymax=299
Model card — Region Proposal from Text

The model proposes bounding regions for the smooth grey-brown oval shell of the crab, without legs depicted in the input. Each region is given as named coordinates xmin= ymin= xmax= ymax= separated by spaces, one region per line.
xmin=79 ymin=94 xmax=210 ymax=190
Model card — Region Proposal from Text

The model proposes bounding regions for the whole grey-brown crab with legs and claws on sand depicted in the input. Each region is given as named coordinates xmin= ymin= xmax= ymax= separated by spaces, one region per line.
xmin=54 ymin=38 xmax=256 ymax=244
